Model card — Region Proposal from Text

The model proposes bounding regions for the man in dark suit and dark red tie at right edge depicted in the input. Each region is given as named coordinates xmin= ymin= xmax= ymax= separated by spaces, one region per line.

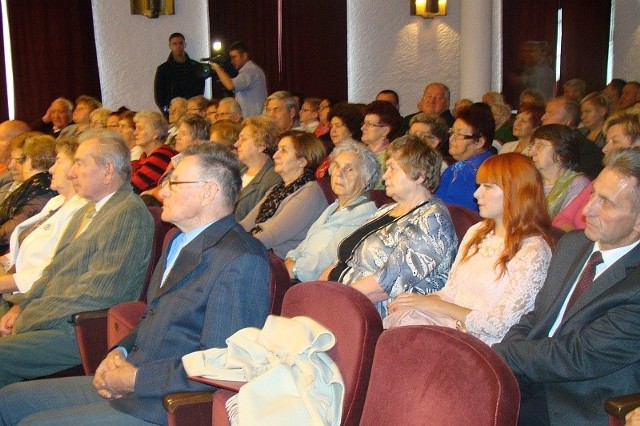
xmin=493 ymin=148 xmax=640 ymax=425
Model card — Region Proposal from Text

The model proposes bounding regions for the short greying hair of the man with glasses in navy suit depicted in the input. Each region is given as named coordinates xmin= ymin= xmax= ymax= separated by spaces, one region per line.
xmin=182 ymin=142 xmax=242 ymax=209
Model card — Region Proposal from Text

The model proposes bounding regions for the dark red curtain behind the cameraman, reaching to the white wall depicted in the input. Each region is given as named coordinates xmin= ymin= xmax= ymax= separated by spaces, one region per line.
xmin=209 ymin=0 xmax=347 ymax=99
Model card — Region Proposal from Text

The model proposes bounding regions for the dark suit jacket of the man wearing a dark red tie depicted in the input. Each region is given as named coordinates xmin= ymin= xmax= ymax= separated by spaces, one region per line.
xmin=493 ymin=231 xmax=640 ymax=425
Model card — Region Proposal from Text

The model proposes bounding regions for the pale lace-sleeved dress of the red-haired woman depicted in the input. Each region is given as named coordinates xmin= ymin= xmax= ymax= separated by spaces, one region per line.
xmin=388 ymin=222 xmax=551 ymax=345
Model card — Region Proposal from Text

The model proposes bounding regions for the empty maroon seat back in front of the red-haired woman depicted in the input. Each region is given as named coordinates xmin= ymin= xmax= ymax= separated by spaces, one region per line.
xmin=360 ymin=326 xmax=520 ymax=426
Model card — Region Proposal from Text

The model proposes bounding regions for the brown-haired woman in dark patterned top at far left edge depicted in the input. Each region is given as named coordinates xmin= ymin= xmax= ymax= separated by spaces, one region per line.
xmin=0 ymin=135 xmax=56 ymax=252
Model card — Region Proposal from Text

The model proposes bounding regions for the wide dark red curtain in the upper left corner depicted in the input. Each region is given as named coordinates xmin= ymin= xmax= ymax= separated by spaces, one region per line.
xmin=7 ymin=0 xmax=101 ymax=122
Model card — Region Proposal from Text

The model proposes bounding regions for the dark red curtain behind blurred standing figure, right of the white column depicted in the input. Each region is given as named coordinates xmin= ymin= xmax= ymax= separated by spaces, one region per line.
xmin=502 ymin=0 xmax=558 ymax=106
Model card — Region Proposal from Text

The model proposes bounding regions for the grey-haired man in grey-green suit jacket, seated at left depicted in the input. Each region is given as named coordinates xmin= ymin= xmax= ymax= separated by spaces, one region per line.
xmin=0 ymin=130 xmax=153 ymax=387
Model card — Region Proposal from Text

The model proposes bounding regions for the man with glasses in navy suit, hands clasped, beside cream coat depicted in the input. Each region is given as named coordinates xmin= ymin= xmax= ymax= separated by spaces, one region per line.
xmin=0 ymin=144 xmax=269 ymax=425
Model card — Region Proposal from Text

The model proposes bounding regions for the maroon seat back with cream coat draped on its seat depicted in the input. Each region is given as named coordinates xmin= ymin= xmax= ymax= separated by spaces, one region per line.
xmin=282 ymin=281 xmax=382 ymax=425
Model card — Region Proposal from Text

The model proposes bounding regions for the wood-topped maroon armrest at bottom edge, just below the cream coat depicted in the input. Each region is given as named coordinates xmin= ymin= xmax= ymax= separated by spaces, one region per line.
xmin=162 ymin=392 xmax=213 ymax=426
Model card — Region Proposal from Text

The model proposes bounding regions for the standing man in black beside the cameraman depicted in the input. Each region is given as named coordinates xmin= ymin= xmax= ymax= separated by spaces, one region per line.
xmin=153 ymin=33 xmax=204 ymax=116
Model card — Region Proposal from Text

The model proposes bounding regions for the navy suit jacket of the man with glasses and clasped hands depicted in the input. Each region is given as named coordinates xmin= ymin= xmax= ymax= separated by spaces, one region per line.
xmin=112 ymin=215 xmax=269 ymax=424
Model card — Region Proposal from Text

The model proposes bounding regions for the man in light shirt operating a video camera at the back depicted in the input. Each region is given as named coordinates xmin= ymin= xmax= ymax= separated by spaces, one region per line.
xmin=210 ymin=41 xmax=268 ymax=117
